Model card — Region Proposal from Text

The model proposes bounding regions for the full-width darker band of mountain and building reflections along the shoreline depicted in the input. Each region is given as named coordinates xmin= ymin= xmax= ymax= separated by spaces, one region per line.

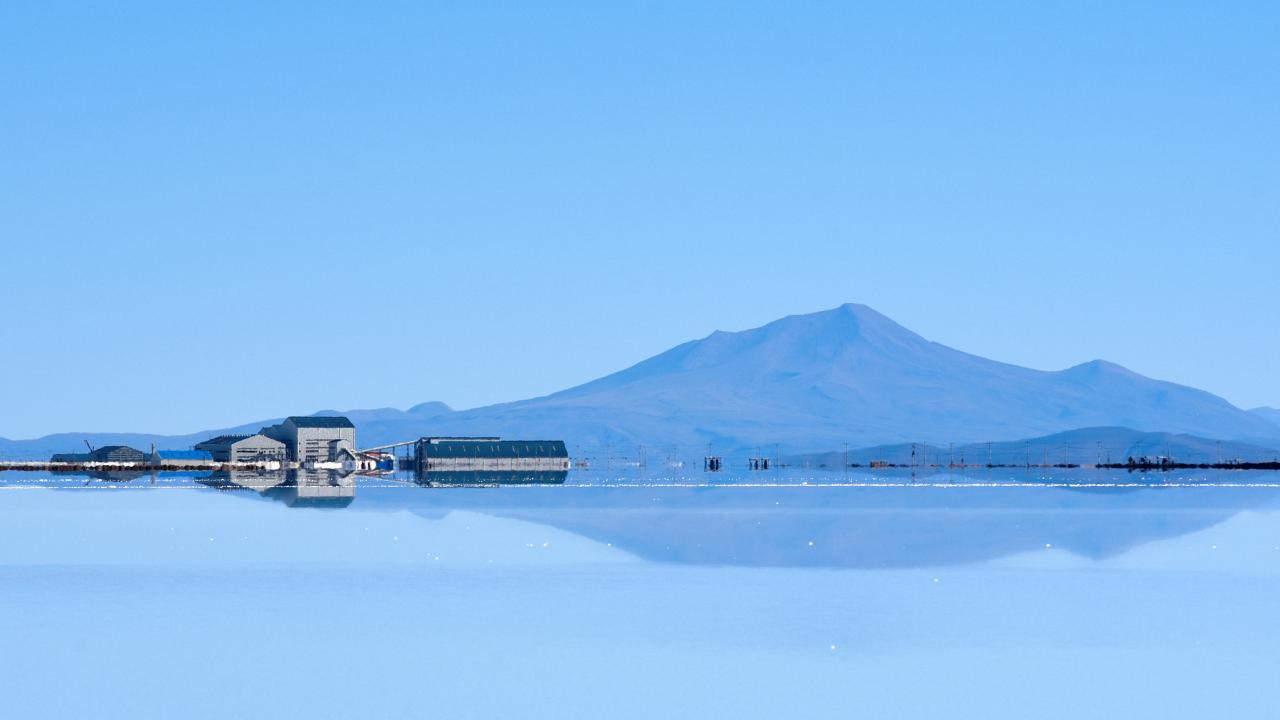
xmin=0 ymin=461 xmax=1280 ymax=569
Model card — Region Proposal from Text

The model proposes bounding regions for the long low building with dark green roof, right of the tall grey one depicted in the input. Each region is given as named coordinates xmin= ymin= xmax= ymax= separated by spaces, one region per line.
xmin=413 ymin=437 xmax=570 ymax=473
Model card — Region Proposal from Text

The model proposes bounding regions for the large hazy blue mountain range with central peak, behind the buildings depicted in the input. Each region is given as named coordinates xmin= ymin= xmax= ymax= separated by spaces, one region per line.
xmin=0 ymin=305 xmax=1280 ymax=457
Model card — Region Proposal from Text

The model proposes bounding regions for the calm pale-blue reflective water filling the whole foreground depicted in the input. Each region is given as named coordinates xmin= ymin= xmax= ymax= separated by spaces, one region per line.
xmin=0 ymin=470 xmax=1280 ymax=719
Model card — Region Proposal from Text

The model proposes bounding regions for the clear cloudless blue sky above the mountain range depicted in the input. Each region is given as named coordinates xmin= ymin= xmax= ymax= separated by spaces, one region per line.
xmin=0 ymin=1 xmax=1280 ymax=438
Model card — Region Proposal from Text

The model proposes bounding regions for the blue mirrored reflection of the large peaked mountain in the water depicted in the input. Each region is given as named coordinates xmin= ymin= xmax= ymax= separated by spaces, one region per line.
xmin=360 ymin=477 xmax=1280 ymax=569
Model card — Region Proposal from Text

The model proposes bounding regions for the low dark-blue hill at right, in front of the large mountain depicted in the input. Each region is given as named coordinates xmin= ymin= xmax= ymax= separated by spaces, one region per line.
xmin=785 ymin=428 xmax=1280 ymax=468
